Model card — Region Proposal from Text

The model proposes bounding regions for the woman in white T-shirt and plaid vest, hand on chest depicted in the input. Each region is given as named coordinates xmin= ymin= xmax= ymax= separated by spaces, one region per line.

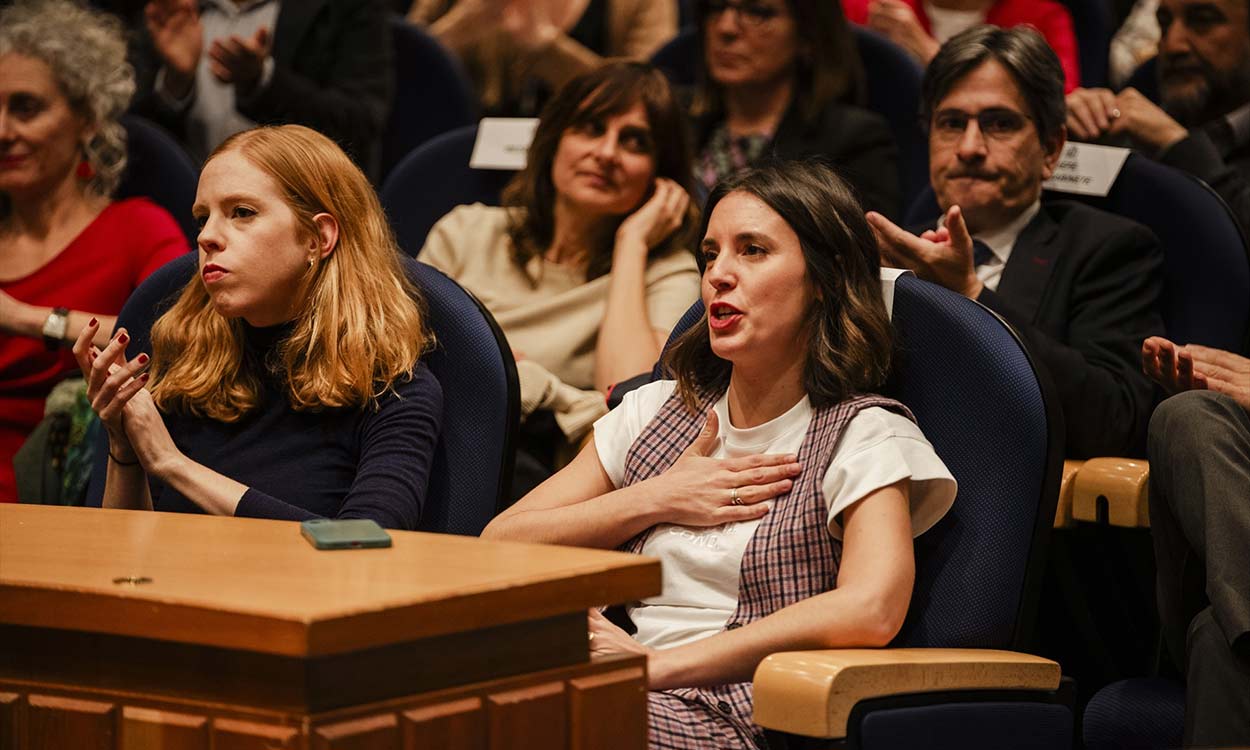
xmin=483 ymin=164 xmax=955 ymax=749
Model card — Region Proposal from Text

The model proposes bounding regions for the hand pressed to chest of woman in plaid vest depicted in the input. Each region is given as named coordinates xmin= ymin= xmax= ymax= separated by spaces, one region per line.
xmin=648 ymin=410 xmax=801 ymax=526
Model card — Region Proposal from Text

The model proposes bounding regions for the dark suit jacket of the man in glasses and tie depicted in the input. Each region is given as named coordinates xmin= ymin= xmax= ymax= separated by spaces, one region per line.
xmin=925 ymin=200 xmax=1164 ymax=459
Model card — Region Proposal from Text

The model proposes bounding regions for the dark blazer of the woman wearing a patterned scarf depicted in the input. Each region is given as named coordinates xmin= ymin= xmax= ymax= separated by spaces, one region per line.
xmin=695 ymin=96 xmax=903 ymax=219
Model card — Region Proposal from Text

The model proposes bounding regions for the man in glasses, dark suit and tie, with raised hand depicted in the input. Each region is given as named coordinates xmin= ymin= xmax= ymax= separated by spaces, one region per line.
xmin=868 ymin=26 xmax=1163 ymax=458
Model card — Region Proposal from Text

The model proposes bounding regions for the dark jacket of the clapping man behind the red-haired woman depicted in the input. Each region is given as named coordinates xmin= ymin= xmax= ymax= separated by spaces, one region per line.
xmin=131 ymin=0 xmax=395 ymax=175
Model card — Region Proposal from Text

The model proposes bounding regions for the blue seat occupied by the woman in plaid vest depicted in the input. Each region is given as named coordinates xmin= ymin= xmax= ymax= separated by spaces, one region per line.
xmin=650 ymin=275 xmax=1074 ymax=749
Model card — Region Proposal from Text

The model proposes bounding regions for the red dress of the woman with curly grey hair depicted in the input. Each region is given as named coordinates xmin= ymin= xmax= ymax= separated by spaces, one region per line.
xmin=0 ymin=198 xmax=188 ymax=503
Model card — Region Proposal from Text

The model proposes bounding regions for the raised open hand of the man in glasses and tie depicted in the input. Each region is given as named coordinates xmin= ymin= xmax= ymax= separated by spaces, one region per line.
xmin=866 ymin=206 xmax=984 ymax=300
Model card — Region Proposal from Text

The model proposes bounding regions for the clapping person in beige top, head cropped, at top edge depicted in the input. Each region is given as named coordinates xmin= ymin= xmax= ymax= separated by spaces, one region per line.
xmin=408 ymin=0 xmax=678 ymax=115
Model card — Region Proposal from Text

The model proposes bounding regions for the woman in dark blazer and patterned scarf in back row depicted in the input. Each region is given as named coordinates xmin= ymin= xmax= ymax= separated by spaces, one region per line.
xmin=691 ymin=0 xmax=901 ymax=216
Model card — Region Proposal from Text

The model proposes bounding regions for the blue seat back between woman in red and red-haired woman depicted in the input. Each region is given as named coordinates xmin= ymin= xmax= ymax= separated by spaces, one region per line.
xmin=115 ymin=115 xmax=200 ymax=248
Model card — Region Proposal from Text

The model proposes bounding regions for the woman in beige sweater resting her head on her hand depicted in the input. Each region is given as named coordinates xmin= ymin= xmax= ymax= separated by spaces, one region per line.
xmin=419 ymin=63 xmax=699 ymax=475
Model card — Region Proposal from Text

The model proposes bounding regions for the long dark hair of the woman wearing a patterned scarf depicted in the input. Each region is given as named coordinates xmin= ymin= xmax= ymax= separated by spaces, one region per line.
xmin=691 ymin=0 xmax=868 ymax=123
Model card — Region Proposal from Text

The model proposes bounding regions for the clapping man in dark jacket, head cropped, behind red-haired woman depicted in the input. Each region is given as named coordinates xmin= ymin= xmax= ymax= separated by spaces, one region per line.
xmin=133 ymin=0 xmax=394 ymax=174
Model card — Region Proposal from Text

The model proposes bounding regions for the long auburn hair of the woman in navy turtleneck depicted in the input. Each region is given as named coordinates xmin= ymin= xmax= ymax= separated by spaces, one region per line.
xmin=150 ymin=125 xmax=433 ymax=423
